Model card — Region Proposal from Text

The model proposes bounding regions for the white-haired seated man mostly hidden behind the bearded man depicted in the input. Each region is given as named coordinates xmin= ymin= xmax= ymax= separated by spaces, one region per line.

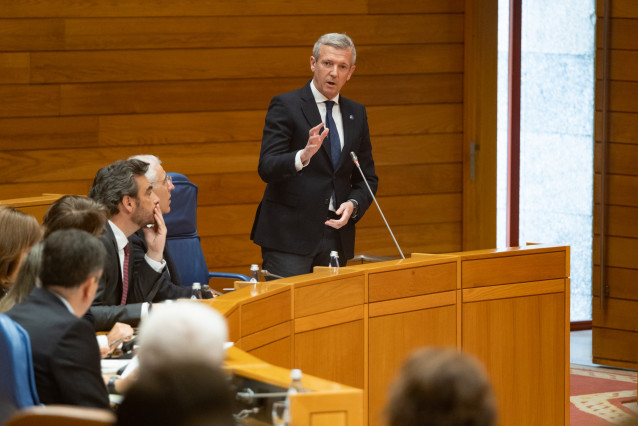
xmin=129 ymin=155 xmax=191 ymax=302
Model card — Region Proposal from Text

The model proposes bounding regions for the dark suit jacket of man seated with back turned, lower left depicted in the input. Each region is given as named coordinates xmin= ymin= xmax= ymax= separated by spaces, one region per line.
xmin=7 ymin=287 xmax=109 ymax=408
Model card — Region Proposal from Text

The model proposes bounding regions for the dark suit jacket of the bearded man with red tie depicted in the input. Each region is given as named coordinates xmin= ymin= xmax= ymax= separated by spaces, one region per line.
xmin=87 ymin=223 xmax=162 ymax=331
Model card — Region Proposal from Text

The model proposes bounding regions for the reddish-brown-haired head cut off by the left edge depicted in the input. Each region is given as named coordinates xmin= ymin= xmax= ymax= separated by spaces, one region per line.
xmin=0 ymin=206 xmax=42 ymax=289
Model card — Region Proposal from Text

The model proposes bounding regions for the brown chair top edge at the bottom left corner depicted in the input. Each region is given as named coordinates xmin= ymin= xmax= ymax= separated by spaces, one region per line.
xmin=5 ymin=405 xmax=116 ymax=426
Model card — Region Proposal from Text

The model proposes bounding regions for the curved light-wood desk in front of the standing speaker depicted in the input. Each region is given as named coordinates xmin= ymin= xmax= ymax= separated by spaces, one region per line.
xmin=205 ymin=245 xmax=569 ymax=425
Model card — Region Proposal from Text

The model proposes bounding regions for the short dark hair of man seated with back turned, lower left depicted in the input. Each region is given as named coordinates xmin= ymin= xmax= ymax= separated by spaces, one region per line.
xmin=40 ymin=229 xmax=106 ymax=288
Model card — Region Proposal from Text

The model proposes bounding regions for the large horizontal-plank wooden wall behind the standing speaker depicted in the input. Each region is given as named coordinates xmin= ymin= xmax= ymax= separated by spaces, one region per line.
xmin=0 ymin=0 xmax=466 ymax=286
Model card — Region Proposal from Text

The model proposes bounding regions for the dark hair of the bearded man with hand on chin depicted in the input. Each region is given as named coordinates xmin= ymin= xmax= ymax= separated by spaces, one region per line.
xmin=89 ymin=160 xmax=148 ymax=216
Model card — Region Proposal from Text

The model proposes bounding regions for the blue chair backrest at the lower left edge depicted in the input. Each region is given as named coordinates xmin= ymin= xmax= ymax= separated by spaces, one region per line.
xmin=0 ymin=314 xmax=40 ymax=420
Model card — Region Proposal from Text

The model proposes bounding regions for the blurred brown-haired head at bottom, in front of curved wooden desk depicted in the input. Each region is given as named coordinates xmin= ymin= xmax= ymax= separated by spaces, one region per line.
xmin=386 ymin=348 xmax=497 ymax=426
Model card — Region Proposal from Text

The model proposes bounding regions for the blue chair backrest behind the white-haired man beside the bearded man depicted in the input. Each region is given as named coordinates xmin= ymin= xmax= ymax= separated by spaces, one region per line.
xmin=164 ymin=173 xmax=214 ymax=286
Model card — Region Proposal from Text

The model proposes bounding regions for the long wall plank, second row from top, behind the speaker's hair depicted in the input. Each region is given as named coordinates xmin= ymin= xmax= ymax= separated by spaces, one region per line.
xmin=66 ymin=14 xmax=463 ymax=50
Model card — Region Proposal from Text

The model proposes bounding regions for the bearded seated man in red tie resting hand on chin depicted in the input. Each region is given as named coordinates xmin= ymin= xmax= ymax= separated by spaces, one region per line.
xmin=88 ymin=160 xmax=171 ymax=331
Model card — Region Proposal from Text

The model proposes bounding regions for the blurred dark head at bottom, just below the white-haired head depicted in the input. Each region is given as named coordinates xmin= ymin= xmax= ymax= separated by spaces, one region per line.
xmin=117 ymin=361 xmax=236 ymax=426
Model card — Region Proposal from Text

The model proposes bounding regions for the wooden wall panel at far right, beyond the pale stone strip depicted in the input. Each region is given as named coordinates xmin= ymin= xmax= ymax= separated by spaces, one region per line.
xmin=592 ymin=0 xmax=638 ymax=368
